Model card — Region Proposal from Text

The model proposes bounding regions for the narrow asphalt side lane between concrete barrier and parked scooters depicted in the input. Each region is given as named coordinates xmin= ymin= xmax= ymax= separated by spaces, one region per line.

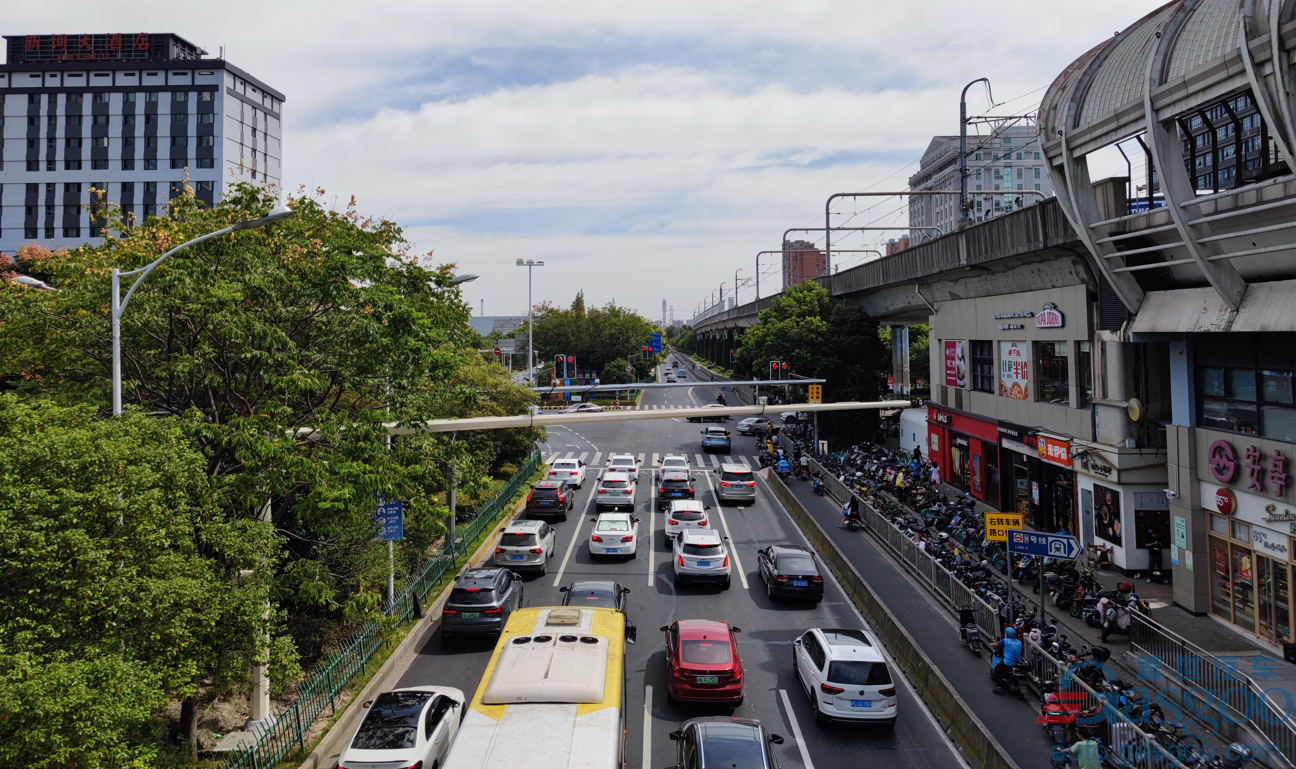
xmin=789 ymin=481 xmax=1052 ymax=766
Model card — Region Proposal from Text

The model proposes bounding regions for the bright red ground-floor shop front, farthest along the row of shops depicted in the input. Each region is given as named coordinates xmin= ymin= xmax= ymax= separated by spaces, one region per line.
xmin=927 ymin=406 xmax=999 ymax=507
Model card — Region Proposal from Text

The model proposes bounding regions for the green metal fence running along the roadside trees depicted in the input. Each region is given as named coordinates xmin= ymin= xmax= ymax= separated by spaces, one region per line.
xmin=218 ymin=451 xmax=543 ymax=769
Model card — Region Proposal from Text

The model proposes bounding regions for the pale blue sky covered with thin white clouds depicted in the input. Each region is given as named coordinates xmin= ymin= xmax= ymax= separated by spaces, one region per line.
xmin=12 ymin=0 xmax=1160 ymax=319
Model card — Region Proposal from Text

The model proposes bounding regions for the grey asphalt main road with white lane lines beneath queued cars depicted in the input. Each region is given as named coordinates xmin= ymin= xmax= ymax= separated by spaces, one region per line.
xmin=399 ymin=357 xmax=966 ymax=769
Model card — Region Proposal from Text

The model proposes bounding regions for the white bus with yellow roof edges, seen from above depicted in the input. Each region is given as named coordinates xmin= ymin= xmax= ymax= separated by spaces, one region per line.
xmin=443 ymin=607 xmax=635 ymax=769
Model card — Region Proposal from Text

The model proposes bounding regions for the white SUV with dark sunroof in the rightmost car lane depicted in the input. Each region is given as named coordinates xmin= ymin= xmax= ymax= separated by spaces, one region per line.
xmin=792 ymin=628 xmax=897 ymax=728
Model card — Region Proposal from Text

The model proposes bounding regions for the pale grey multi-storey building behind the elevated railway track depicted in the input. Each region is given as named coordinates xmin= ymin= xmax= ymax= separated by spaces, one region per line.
xmin=908 ymin=123 xmax=1052 ymax=233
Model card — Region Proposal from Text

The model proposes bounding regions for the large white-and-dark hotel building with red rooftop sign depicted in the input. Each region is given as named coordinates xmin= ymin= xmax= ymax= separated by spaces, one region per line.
xmin=0 ymin=32 xmax=284 ymax=254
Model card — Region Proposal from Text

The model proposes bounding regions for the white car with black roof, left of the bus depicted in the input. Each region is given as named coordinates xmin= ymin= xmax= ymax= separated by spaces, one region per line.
xmin=337 ymin=686 xmax=465 ymax=766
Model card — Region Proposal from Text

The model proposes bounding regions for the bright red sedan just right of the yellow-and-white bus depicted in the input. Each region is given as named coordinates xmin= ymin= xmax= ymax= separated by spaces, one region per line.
xmin=661 ymin=620 xmax=743 ymax=707
